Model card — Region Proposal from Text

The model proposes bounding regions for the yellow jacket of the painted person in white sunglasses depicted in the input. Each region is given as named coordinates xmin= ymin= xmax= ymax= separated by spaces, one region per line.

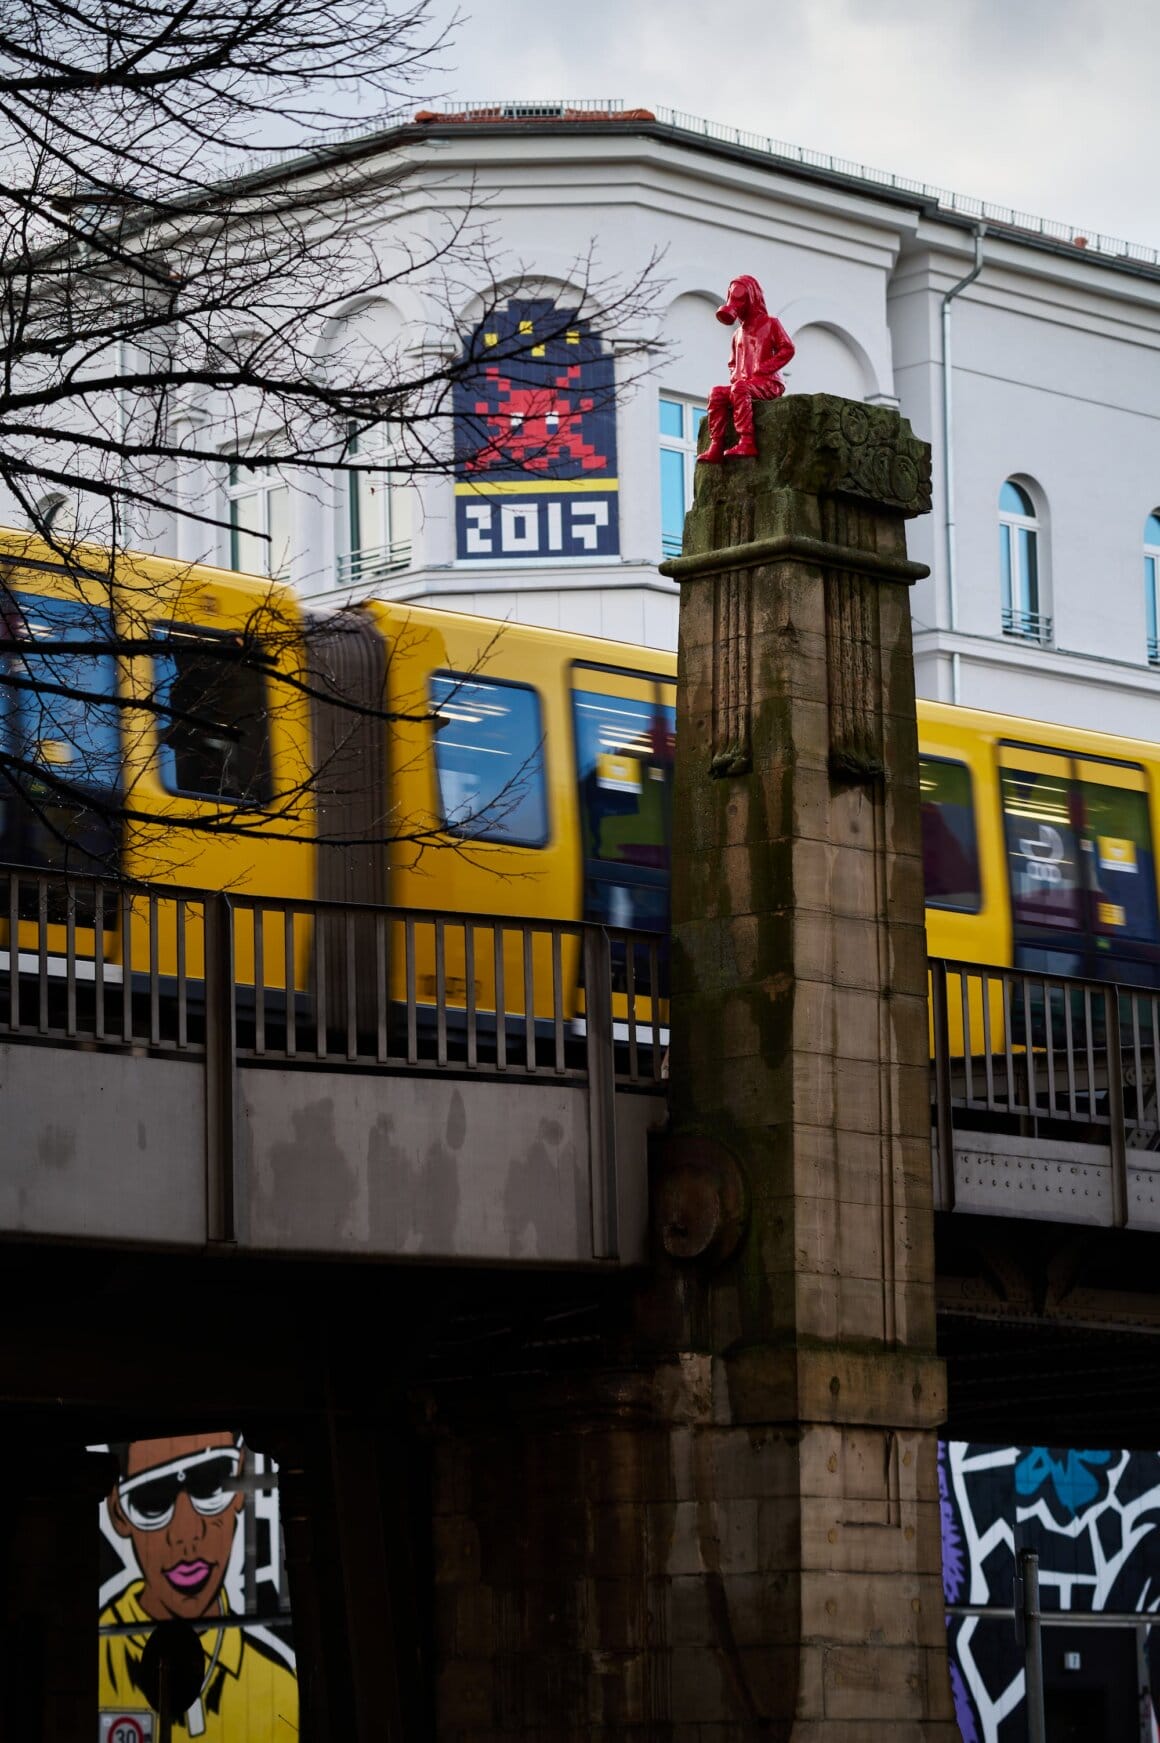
xmin=99 ymin=1579 xmax=298 ymax=1743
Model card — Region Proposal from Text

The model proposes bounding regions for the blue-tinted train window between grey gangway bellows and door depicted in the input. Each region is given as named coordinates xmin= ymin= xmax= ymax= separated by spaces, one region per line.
xmin=430 ymin=673 xmax=547 ymax=847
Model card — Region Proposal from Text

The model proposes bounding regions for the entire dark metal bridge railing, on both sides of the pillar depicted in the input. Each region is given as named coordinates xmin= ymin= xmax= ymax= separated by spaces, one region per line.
xmin=11 ymin=850 xmax=1160 ymax=1225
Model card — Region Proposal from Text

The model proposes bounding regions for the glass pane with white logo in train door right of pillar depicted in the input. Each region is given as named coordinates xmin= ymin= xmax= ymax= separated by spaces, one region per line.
xmin=1000 ymin=769 xmax=1082 ymax=931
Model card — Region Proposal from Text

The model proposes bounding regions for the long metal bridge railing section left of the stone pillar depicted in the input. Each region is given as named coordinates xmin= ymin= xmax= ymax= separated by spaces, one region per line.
xmin=0 ymin=868 xmax=669 ymax=1086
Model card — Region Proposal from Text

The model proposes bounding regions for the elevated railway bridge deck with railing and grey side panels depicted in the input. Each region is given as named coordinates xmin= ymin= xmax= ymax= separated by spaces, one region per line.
xmin=0 ymin=868 xmax=1160 ymax=1443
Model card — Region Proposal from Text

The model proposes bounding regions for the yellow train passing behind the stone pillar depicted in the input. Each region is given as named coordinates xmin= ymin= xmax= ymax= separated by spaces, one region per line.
xmin=0 ymin=533 xmax=1160 ymax=999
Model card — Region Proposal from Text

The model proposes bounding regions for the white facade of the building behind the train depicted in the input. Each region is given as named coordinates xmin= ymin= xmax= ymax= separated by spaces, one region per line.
xmin=13 ymin=117 xmax=1160 ymax=739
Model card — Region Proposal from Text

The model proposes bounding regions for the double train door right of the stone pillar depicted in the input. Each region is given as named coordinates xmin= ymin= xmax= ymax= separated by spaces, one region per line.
xmin=998 ymin=743 xmax=1160 ymax=987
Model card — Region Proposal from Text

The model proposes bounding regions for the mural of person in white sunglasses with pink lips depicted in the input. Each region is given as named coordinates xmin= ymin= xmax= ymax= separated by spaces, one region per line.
xmin=98 ymin=1431 xmax=298 ymax=1743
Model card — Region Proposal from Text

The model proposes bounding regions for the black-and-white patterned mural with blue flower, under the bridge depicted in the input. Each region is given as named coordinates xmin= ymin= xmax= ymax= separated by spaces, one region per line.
xmin=939 ymin=1441 xmax=1160 ymax=1743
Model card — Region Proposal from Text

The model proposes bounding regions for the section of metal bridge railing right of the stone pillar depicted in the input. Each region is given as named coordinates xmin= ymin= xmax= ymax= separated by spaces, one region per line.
xmin=930 ymin=960 xmax=1160 ymax=1227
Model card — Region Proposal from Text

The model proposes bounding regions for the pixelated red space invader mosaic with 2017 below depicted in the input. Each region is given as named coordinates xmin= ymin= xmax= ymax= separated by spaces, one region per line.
xmin=455 ymin=298 xmax=620 ymax=563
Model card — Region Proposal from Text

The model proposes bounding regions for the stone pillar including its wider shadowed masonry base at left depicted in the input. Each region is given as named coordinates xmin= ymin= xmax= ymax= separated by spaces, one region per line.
xmin=425 ymin=396 xmax=958 ymax=1743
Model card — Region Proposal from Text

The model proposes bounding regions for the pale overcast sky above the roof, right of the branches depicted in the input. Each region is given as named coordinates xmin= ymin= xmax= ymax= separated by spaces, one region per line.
xmin=418 ymin=0 xmax=1160 ymax=248
